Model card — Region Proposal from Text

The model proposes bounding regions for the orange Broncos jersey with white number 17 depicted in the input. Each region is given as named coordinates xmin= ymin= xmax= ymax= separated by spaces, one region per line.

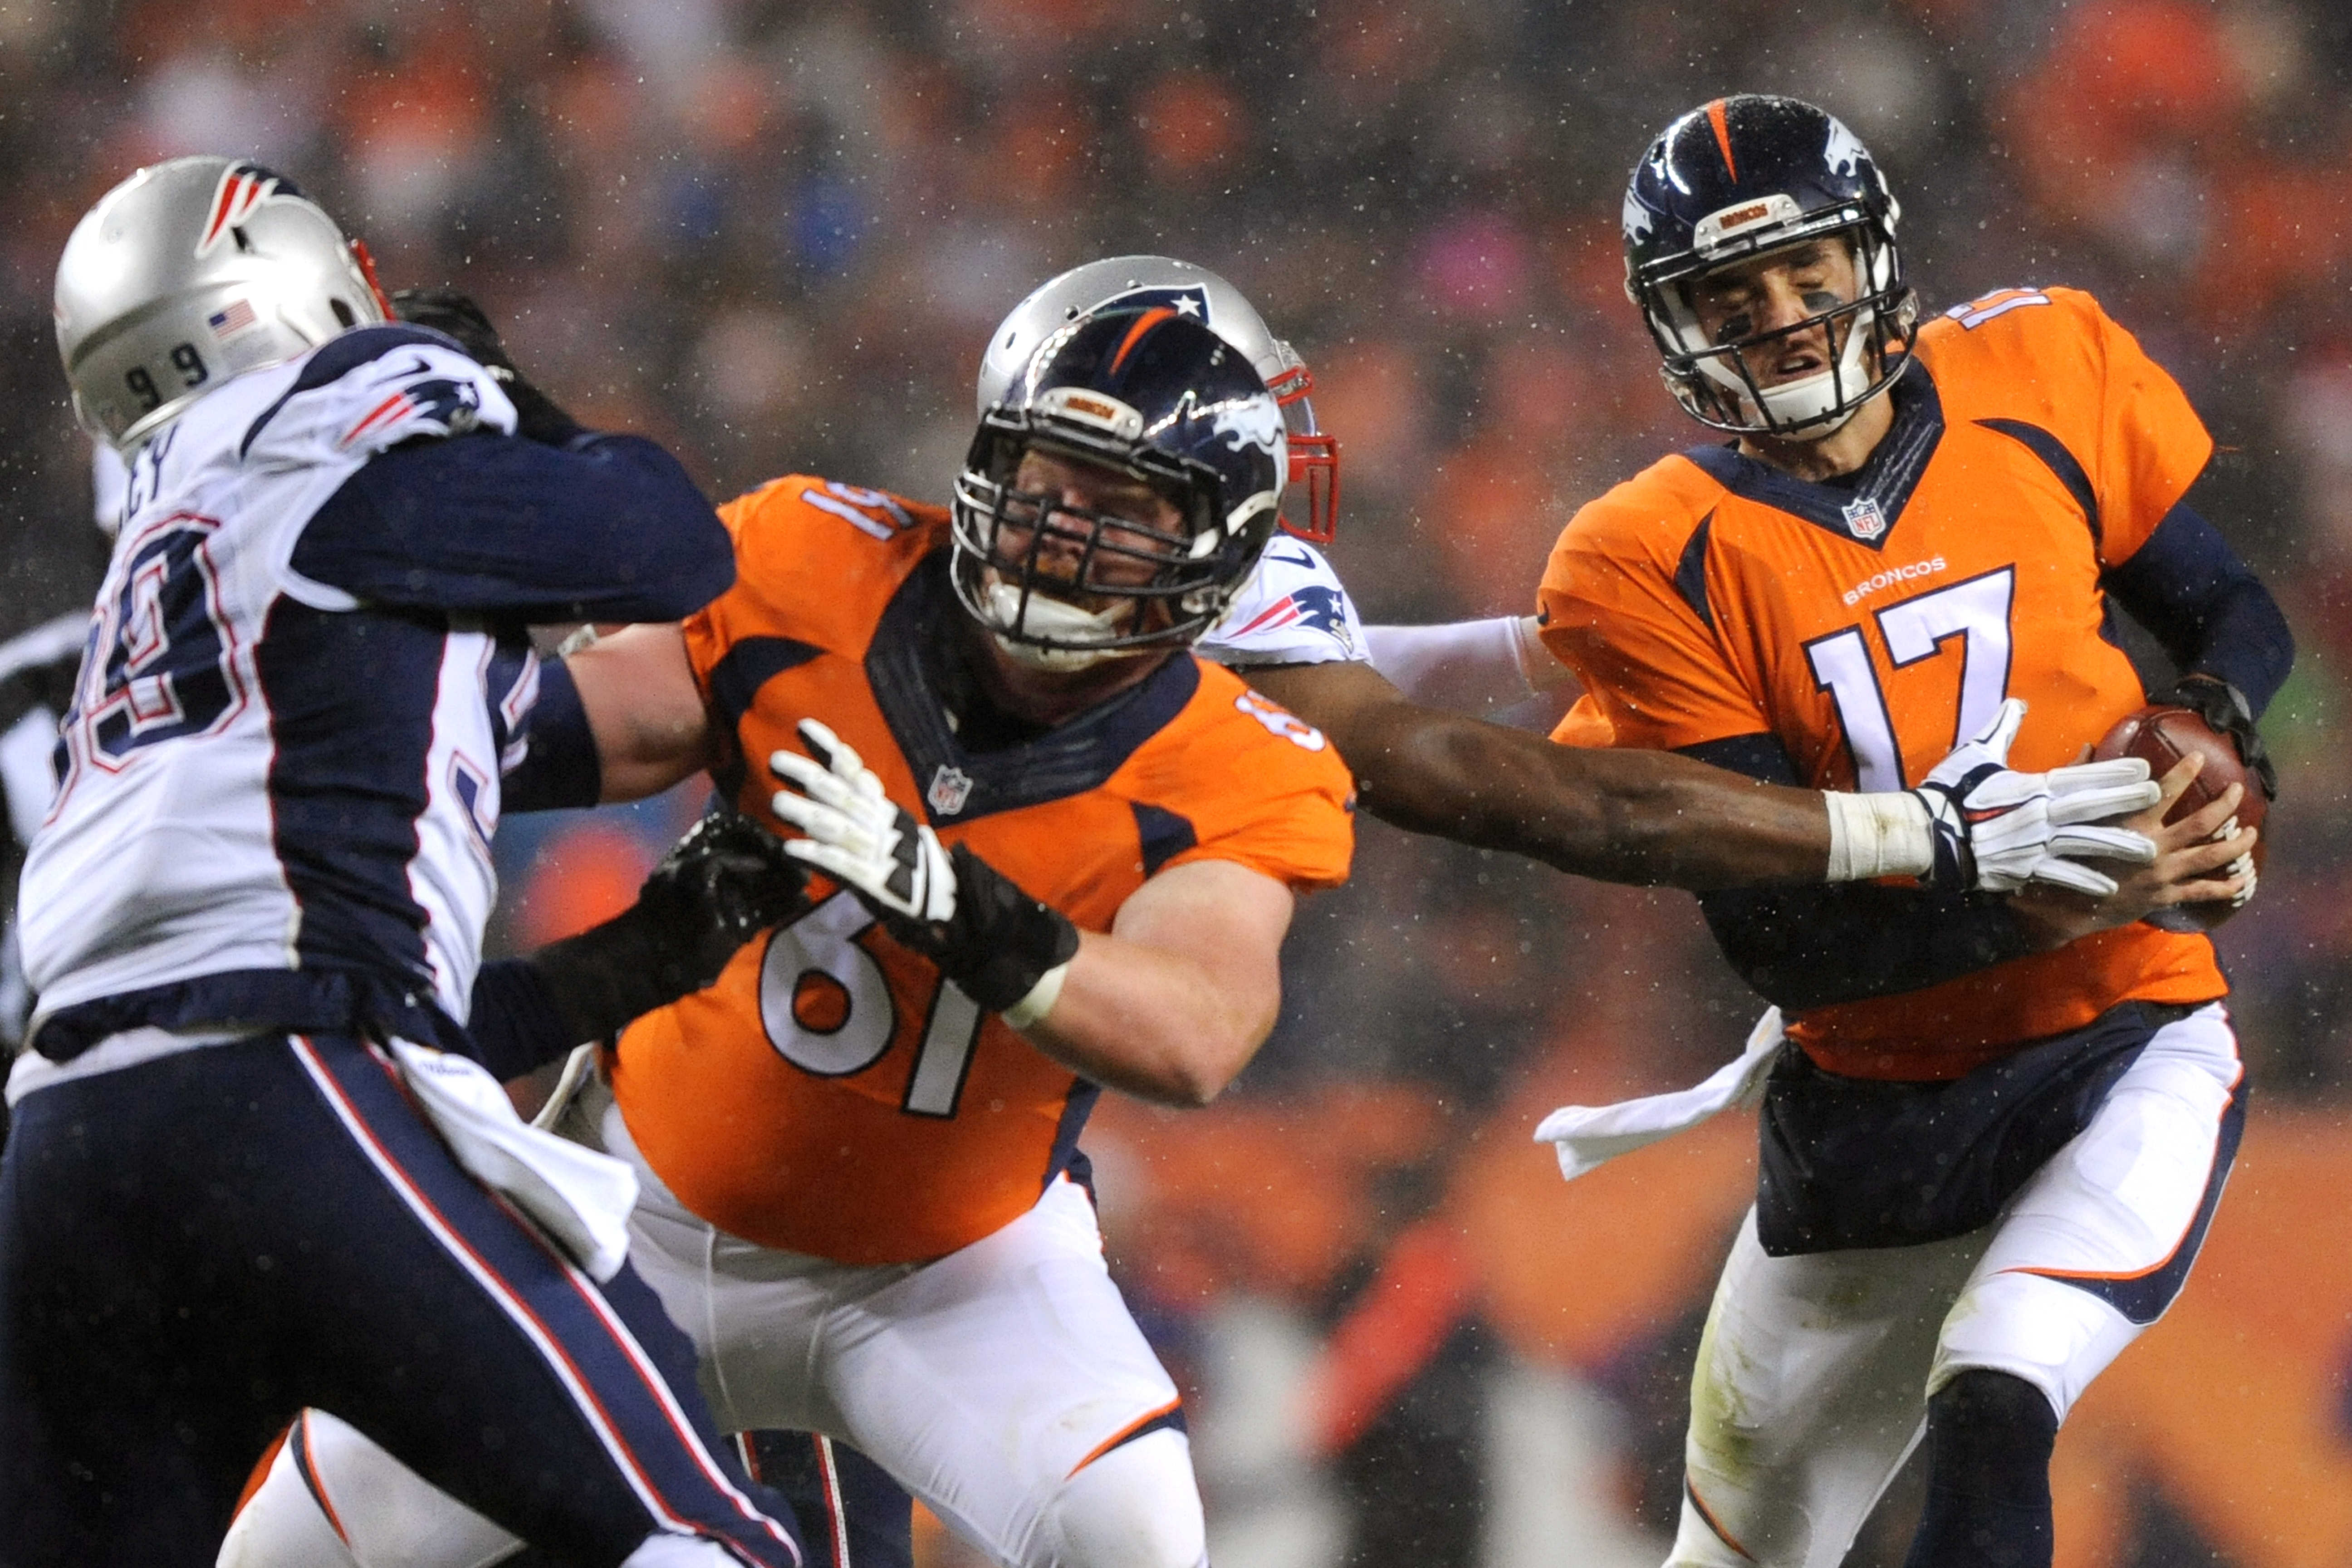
xmin=1538 ymin=289 xmax=2227 ymax=1079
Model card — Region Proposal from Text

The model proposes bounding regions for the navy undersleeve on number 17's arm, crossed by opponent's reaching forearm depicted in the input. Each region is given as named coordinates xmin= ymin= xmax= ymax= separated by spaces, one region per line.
xmin=1682 ymin=736 xmax=2032 ymax=1013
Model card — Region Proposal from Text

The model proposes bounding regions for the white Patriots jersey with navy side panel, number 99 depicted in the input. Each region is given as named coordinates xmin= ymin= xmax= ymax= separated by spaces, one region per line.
xmin=19 ymin=327 xmax=519 ymax=1029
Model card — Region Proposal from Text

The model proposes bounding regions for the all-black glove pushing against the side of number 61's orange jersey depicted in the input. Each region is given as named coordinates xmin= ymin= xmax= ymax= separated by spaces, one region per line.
xmin=529 ymin=811 xmax=809 ymax=1039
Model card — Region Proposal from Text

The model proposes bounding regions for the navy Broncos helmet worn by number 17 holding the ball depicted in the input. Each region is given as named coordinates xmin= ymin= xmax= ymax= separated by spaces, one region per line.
xmin=1625 ymin=94 xmax=1919 ymax=437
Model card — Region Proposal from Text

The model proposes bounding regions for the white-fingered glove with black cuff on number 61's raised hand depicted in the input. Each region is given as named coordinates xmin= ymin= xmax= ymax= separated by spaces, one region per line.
xmin=767 ymin=720 xmax=1077 ymax=1027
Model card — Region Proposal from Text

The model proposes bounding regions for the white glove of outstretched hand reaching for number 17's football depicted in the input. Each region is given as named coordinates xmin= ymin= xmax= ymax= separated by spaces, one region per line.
xmin=1912 ymin=698 xmax=2161 ymax=898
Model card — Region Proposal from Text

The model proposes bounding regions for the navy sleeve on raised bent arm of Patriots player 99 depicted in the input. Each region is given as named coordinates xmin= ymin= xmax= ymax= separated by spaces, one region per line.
xmin=294 ymin=432 xmax=734 ymax=623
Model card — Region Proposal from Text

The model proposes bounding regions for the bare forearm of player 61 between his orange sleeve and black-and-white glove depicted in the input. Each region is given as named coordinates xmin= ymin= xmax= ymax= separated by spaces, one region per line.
xmin=1025 ymin=931 xmax=1282 ymax=1107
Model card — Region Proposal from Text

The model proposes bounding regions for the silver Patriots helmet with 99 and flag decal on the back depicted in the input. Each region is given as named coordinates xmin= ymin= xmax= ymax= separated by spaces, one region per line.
xmin=56 ymin=155 xmax=388 ymax=451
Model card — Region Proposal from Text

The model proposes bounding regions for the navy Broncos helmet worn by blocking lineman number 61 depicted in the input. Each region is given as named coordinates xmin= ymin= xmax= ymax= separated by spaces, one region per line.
xmin=955 ymin=306 xmax=1289 ymax=670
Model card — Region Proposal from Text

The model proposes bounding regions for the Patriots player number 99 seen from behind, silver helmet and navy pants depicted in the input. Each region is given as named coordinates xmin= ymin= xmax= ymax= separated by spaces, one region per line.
xmin=0 ymin=157 xmax=800 ymax=1568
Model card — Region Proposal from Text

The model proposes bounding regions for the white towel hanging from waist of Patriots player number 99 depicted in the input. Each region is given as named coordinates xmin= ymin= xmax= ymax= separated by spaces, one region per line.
xmin=393 ymin=1039 xmax=637 ymax=1284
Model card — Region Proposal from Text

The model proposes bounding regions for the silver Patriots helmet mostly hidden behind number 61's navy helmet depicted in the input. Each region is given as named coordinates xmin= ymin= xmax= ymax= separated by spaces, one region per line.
xmin=979 ymin=256 xmax=1338 ymax=545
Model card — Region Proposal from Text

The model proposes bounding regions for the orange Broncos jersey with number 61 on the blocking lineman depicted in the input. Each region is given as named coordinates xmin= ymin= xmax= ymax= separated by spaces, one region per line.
xmin=612 ymin=477 xmax=1352 ymax=1262
